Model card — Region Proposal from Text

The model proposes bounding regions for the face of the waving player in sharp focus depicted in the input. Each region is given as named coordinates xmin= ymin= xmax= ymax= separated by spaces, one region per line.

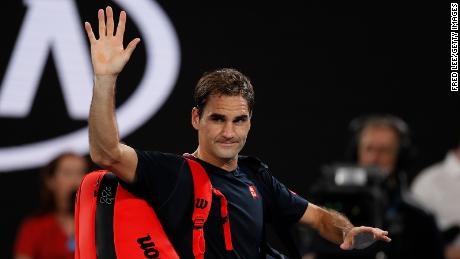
xmin=192 ymin=95 xmax=251 ymax=164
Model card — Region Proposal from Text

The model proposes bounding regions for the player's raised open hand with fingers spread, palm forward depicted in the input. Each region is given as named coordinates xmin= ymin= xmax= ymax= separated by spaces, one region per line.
xmin=85 ymin=6 xmax=140 ymax=76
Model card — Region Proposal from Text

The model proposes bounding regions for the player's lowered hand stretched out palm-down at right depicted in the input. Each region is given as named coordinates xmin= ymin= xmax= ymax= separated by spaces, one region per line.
xmin=340 ymin=227 xmax=391 ymax=250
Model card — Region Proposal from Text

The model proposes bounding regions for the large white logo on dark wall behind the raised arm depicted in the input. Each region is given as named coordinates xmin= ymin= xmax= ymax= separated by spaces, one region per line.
xmin=0 ymin=0 xmax=180 ymax=171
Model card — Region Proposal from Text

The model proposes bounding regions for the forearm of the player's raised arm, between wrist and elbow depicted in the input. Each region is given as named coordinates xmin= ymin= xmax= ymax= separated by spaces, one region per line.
xmin=88 ymin=75 xmax=121 ymax=166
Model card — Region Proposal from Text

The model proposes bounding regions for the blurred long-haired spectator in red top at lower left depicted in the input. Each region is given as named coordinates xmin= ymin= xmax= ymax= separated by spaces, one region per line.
xmin=14 ymin=153 xmax=88 ymax=259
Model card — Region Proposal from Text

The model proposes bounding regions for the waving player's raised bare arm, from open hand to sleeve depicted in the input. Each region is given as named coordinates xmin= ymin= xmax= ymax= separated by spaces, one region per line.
xmin=85 ymin=7 xmax=140 ymax=182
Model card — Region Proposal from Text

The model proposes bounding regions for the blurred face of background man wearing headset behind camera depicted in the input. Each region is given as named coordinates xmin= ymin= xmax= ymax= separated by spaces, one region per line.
xmin=358 ymin=126 xmax=399 ymax=177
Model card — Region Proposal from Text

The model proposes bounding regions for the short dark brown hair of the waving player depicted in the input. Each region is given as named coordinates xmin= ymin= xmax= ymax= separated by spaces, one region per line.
xmin=193 ymin=68 xmax=254 ymax=117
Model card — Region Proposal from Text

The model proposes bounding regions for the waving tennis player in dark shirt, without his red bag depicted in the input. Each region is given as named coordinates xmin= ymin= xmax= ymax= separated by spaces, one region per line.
xmin=85 ymin=7 xmax=390 ymax=258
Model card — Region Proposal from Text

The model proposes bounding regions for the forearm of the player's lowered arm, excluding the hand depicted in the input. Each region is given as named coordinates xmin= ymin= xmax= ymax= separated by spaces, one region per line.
xmin=316 ymin=208 xmax=353 ymax=244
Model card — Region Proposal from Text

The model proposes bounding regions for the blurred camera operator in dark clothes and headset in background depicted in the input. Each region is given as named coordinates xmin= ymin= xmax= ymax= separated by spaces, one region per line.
xmin=304 ymin=114 xmax=444 ymax=259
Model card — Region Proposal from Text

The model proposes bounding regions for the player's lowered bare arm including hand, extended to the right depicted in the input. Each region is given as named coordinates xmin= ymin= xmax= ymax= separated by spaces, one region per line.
xmin=300 ymin=203 xmax=391 ymax=250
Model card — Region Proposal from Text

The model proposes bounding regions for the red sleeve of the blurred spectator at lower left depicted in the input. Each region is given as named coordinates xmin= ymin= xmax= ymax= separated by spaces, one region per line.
xmin=14 ymin=219 xmax=40 ymax=257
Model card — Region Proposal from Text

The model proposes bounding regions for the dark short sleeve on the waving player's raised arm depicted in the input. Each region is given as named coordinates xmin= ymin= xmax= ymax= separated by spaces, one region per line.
xmin=122 ymin=150 xmax=185 ymax=209
